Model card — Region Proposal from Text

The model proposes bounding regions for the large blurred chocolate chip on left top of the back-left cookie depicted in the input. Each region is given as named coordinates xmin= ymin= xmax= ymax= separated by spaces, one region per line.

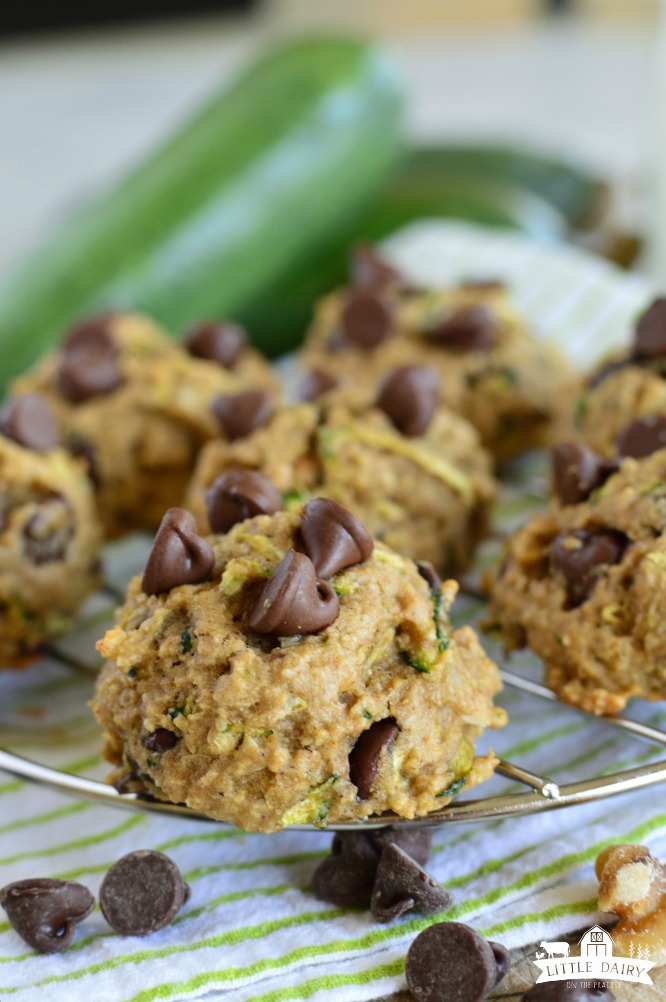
xmin=56 ymin=315 xmax=123 ymax=404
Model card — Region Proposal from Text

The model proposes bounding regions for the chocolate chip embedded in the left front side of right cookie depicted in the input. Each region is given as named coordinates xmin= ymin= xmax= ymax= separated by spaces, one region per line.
xmin=551 ymin=529 xmax=629 ymax=608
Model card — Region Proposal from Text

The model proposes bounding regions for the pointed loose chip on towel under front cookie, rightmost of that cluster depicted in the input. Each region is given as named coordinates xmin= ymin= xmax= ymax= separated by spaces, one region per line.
xmin=371 ymin=843 xmax=453 ymax=922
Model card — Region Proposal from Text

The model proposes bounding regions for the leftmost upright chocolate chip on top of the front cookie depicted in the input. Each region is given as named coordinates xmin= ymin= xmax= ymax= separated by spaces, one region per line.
xmin=141 ymin=508 xmax=215 ymax=595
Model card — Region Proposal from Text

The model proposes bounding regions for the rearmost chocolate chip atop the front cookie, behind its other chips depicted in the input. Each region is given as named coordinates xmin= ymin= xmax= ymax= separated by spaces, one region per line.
xmin=206 ymin=470 xmax=282 ymax=532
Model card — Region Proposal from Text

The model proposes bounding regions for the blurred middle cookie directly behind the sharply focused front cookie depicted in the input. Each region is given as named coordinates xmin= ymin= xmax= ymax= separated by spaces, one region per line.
xmin=185 ymin=366 xmax=495 ymax=572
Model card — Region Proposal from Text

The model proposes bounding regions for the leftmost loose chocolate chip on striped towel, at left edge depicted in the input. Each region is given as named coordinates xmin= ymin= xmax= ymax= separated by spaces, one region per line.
xmin=0 ymin=878 xmax=95 ymax=953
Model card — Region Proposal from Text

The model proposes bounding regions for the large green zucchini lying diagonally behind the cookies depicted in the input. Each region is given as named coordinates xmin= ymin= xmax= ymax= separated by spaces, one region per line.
xmin=0 ymin=38 xmax=401 ymax=382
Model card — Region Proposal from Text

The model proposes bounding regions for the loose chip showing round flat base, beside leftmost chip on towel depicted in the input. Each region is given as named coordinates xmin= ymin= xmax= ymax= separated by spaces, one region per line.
xmin=99 ymin=849 xmax=189 ymax=936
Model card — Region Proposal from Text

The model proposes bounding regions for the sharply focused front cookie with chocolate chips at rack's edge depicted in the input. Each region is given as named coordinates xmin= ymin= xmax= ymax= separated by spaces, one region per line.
xmin=93 ymin=498 xmax=506 ymax=832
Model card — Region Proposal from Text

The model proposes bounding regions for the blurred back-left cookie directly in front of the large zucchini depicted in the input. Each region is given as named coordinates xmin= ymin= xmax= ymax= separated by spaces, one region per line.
xmin=13 ymin=314 xmax=275 ymax=537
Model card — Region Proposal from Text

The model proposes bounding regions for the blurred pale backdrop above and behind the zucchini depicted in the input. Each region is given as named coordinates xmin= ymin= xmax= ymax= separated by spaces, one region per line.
xmin=0 ymin=0 xmax=666 ymax=322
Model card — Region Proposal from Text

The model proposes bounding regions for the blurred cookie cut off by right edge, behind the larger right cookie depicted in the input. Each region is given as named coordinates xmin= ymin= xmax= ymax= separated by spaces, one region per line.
xmin=576 ymin=299 xmax=666 ymax=459
